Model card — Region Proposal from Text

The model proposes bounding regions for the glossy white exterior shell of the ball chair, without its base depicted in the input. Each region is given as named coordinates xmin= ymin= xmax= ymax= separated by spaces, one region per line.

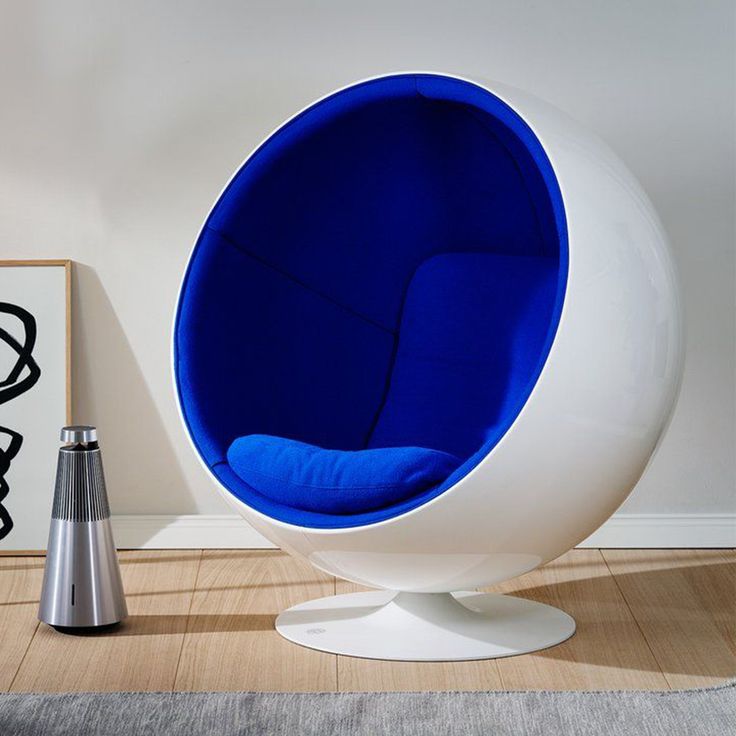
xmin=174 ymin=75 xmax=682 ymax=592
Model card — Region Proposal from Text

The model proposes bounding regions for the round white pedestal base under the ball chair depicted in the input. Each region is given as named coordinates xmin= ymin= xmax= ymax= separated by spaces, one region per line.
xmin=276 ymin=591 xmax=575 ymax=661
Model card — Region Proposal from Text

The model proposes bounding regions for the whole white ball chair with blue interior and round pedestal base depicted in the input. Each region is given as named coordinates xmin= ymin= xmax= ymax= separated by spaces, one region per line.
xmin=173 ymin=73 xmax=681 ymax=660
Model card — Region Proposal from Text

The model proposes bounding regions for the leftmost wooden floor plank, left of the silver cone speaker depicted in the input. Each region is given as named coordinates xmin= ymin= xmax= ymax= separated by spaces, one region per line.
xmin=0 ymin=557 xmax=44 ymax=692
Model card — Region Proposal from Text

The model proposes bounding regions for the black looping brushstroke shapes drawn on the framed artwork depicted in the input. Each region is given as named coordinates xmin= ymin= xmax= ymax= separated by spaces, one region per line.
xmin=0 ymin=302 xmax=41 ymax=540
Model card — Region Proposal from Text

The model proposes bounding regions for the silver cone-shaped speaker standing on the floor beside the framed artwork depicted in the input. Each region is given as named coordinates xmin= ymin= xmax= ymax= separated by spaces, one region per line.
xmin=38 ymin=426 xmax=128 ymax=631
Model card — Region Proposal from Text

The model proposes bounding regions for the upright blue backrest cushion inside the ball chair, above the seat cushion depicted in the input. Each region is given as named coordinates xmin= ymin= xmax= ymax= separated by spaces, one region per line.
xmin=369 ymin=253 xmax=557 ymax=457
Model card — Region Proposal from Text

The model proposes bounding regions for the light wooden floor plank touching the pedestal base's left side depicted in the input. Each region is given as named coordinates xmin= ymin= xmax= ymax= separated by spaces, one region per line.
xmin=175 ymin=550 xmax=337 ymax=691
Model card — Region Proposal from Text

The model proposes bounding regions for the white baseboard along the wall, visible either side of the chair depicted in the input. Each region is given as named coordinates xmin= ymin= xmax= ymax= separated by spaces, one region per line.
xmin=112 ymin=514 xmax=736 ymax=549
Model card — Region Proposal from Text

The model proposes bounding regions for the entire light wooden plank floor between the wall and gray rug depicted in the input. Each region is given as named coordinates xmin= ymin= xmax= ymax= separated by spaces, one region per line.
xmin=0 ymin=549 xmax=736 ymax=691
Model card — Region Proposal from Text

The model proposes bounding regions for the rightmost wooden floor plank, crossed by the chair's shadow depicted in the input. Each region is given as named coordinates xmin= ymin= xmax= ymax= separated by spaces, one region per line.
xmin=603 ymin=550 xmax=736 ymax=688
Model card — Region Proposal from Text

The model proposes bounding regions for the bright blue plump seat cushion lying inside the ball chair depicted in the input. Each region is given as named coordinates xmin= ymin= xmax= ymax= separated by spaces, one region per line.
xmin=227 ymin=434 xmax=461 ymax=514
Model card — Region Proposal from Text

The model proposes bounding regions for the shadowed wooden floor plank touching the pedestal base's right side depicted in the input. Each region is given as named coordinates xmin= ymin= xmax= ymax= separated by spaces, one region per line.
xmin=489 ymin=549 xmax=668 ymax=690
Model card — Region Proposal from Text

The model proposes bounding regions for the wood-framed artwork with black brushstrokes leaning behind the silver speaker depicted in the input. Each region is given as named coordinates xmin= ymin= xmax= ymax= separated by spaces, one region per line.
xmin=0 ymin=260 xmax=72 ymax=551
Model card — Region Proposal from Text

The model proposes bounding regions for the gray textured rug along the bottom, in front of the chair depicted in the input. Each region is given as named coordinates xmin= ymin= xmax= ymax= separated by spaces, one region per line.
xmin=0 ymin=683 xmax=736 ymax=736
